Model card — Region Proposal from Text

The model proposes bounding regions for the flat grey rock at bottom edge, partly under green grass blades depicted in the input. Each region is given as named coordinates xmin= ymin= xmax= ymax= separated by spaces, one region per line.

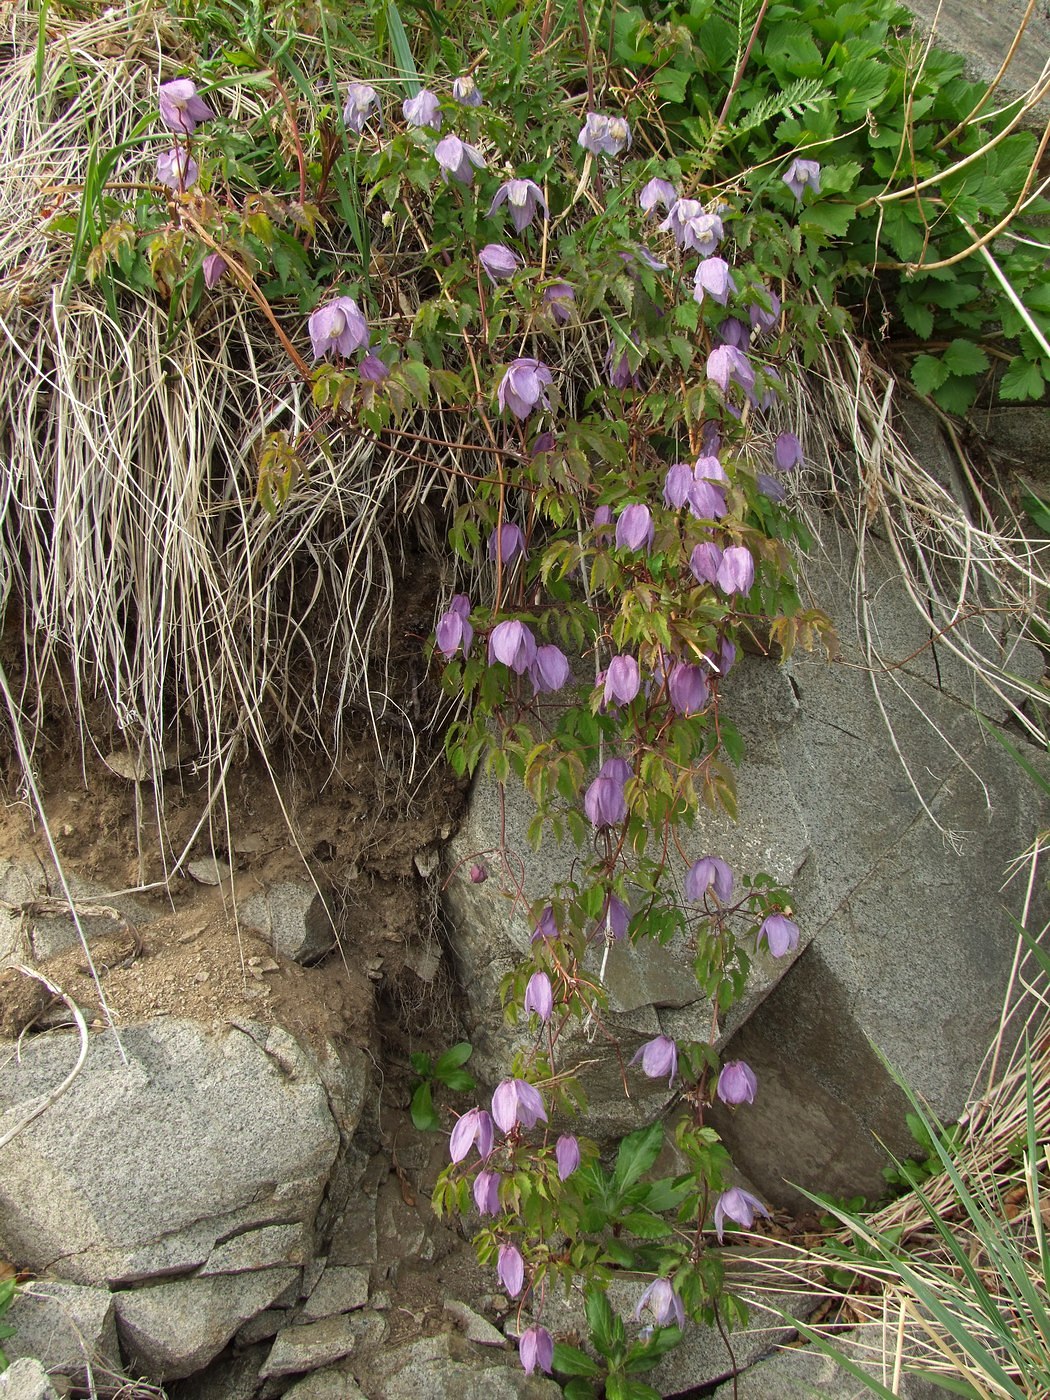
xmin=714 ymin=1333 xmax=945 ymax=1400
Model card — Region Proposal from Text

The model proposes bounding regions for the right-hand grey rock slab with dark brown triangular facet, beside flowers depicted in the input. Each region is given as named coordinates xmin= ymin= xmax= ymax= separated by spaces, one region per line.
xmin=711 ymin=526 xmax=1046 ymax=1204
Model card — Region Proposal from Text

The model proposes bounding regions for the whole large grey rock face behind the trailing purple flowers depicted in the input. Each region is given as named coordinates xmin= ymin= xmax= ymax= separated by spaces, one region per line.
xmin=448 ymin=525 xmax=1043 ymax=1204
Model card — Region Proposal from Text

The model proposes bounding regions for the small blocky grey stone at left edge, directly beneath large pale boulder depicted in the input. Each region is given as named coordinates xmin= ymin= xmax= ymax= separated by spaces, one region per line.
xmin=4 ymin=1280 xmax=120 ymax=1378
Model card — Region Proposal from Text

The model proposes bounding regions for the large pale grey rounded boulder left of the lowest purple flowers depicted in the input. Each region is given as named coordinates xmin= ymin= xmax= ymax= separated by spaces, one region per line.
xmin=0 ymin=1019 xmax=367 ymax=1282
